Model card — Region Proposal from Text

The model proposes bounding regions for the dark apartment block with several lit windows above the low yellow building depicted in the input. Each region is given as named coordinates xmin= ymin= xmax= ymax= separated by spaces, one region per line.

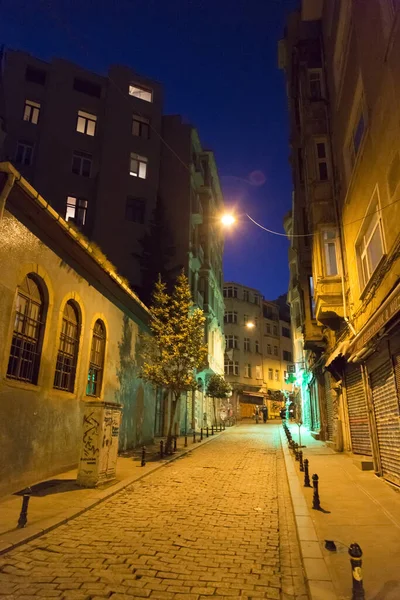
xmin=0 ymin=50 xmax=162 ymax=287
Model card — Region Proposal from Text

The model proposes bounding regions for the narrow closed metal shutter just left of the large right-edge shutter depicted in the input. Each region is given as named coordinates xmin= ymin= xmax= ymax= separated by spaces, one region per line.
xmin=345 ymin=365 xmax=372 ymax=456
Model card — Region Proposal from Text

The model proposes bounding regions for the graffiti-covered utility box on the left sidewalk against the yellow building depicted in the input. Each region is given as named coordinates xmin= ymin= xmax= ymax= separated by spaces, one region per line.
xmin=77 ymin=402 xmax=122 ymax=487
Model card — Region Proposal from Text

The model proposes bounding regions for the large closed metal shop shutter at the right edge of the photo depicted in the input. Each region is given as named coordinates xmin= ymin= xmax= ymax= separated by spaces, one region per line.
xmin=371 ymin=356 xmax=400 ymax=485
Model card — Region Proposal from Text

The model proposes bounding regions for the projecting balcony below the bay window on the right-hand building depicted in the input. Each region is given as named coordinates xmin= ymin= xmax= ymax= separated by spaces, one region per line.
xmin=314 ymin=276 xmax=344 ymax=331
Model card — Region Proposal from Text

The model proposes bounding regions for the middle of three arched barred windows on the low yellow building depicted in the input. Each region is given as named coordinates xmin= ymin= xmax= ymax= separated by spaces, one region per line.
xmin=53 ymin=300 xmax=80 ymax=392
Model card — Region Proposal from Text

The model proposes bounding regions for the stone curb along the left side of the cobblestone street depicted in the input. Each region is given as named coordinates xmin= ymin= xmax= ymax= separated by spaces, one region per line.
xmin=0 ymin=428 xmax=225 ymax=556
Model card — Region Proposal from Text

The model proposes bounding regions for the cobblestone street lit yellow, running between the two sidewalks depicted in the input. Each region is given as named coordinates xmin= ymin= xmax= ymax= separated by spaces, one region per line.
xmin=0 ymin=424 xmax=307 ymax=600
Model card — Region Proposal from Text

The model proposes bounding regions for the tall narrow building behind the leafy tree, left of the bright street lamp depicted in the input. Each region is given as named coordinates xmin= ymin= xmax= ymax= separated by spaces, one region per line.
xmin=159 ymin=115 xmax=225 ymax=428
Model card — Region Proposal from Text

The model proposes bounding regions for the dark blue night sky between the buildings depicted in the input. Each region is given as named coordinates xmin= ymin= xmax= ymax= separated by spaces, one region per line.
xmin=0 ymin=0 xmax=297 ymax=299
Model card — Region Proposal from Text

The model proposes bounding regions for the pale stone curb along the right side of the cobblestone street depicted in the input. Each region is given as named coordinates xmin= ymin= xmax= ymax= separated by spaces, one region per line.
xmin=279 ymin=428 xmax=338 ymax=600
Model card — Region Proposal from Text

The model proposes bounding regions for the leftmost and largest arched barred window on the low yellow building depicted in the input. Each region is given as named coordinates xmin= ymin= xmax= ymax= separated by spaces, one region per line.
xmin=7 ymin=273 xmax=46 ymax=383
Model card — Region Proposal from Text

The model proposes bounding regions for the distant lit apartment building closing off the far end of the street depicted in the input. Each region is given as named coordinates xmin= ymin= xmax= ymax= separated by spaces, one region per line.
xmin=224 ymin=282 xmax=292 ymax=417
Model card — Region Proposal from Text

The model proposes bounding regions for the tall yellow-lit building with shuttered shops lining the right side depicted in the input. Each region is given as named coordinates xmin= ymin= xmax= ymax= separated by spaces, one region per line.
xmin=279 ymin=0 xmax=400 ymax=485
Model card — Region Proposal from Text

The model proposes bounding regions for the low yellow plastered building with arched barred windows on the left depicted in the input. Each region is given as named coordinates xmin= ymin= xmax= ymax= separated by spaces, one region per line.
xmin=0 ymin=163 xmax=164 ymax=493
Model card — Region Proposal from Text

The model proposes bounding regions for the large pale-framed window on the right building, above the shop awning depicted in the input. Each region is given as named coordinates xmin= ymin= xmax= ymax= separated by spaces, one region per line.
xmin=356 ymin=191 xmax=384 ymax=289
